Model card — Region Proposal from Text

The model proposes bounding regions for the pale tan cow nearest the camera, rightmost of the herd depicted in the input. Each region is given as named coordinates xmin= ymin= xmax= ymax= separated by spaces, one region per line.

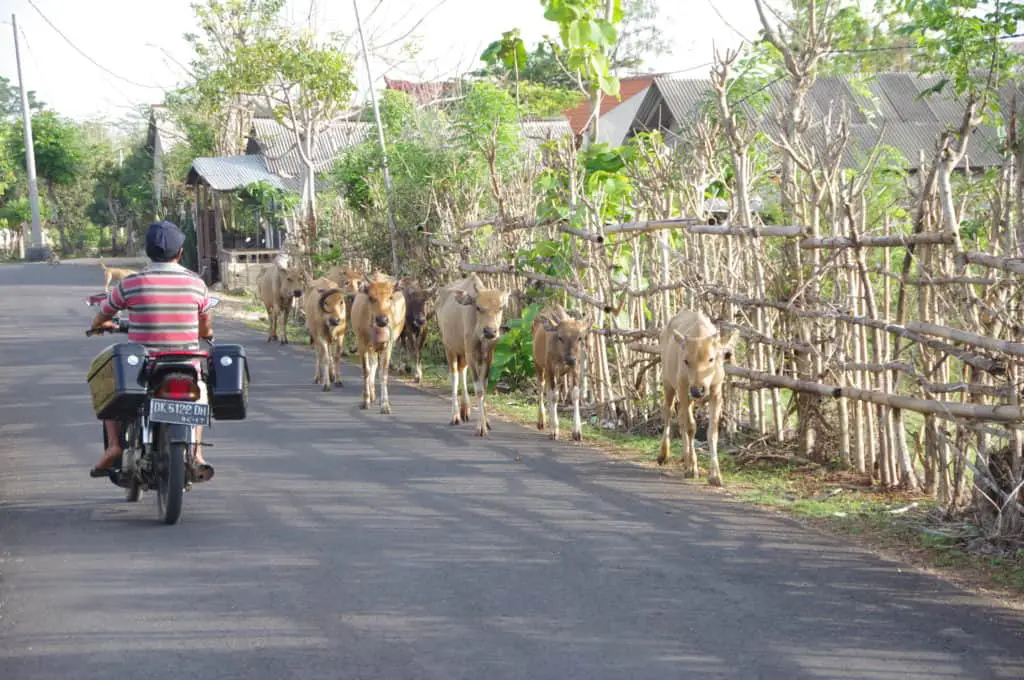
xmin=657 ymin=309 xmax=736 ymax=486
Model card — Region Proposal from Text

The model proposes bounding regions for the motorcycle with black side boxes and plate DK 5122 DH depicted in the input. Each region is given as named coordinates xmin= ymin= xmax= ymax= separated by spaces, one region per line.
xmin=85 ymin=293 xmax=249 ymax=524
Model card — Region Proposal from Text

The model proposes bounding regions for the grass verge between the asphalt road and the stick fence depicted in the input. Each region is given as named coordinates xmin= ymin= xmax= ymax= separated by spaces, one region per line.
xmin=220 ymin=300 xmax=1024 ymax=610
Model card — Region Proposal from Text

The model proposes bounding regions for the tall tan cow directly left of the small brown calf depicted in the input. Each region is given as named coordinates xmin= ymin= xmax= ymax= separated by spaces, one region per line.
xmin=436 ymin=273 xmax=509 ymax=436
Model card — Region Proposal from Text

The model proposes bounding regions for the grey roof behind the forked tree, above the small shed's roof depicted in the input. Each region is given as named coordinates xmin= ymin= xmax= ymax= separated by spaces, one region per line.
xmin=253 ymin=118 xmax=373 ymax=177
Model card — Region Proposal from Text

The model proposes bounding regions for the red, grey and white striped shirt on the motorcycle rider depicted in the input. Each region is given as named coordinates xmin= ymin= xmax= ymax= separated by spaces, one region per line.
xmin=102 ymin=262 xmax=210 ymax=349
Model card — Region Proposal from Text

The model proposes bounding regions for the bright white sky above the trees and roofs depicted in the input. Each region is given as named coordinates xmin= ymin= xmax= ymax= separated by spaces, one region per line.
xmin=0 ymin=0 xmax=760 ymax=121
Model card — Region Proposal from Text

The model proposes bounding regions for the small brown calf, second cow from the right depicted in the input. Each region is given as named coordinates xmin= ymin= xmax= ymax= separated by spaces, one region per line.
xmin=531 ymin=303 xmax=591 ymax=441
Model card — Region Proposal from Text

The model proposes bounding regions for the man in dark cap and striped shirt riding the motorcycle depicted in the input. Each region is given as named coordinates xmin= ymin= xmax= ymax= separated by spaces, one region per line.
xmin=89 ymin=220 xmax=214 ymax=481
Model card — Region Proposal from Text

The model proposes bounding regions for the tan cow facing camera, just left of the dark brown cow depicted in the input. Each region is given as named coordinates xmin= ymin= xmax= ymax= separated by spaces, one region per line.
xmin=352 ymin=272 xmax=406 ymax=414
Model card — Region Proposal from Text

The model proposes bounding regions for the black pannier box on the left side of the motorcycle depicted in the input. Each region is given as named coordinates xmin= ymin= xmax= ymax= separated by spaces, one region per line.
xmin=89 ymin=342 xmax=145 ymax=420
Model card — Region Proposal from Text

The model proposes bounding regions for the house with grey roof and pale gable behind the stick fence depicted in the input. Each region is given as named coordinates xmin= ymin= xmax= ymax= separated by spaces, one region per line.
xmin=614 ymin=73 xmax=1024 ymax=172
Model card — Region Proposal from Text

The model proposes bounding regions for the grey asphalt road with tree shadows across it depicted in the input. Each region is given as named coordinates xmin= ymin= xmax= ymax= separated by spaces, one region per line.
xmin=0 ymin=263 xmax=1024 ymax=680
